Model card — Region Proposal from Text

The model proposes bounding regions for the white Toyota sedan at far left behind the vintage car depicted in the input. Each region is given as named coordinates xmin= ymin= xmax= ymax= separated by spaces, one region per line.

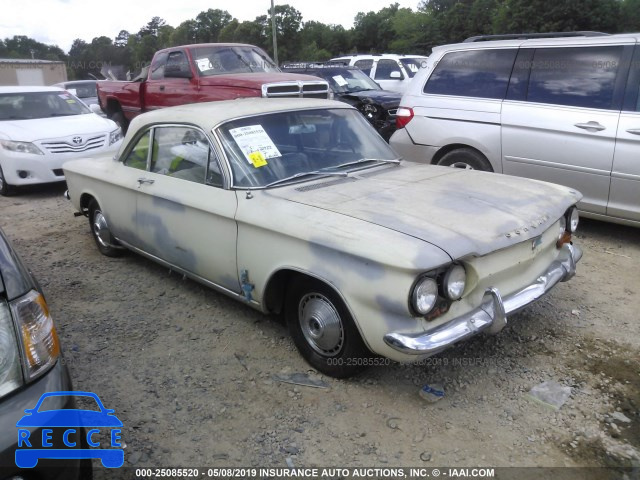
xmin=0 ymin=87 xmax=122 ymax=195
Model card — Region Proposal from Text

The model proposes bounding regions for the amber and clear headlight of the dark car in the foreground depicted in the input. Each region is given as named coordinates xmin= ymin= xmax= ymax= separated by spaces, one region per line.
xmin=11 ymin=290 xmax=60 ymax=381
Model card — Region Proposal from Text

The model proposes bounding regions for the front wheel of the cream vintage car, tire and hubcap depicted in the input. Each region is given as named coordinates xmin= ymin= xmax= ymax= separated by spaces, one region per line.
xmin=285 ymin=277 xmax=368 ymax=378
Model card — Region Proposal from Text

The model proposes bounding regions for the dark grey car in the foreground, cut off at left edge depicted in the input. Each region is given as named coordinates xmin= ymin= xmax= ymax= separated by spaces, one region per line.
xmin=0 ymin=230 xmax=92 ymax=480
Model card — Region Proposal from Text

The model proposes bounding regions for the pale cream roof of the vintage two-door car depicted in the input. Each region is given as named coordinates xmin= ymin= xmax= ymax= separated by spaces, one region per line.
xmin=125 ymin=98 xmax=353 ymax=135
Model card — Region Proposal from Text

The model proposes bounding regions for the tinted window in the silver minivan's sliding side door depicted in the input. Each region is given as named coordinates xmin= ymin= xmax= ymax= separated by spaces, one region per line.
xmin=527 ymin=46 xmax=623 ymax=110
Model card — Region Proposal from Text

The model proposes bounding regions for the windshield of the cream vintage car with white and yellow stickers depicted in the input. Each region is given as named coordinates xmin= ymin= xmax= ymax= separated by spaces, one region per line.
xmin=216 ymin=108 xmax=398 ymax=188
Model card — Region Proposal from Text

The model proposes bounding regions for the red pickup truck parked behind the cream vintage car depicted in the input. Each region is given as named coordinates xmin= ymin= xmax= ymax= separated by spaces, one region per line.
xmin=98 ymin=43 xmax=329 ymax=131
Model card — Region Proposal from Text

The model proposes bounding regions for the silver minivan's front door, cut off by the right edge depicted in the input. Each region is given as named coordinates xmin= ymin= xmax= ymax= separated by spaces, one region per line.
xmin=607 ymin=46 xmax=640 ymax=221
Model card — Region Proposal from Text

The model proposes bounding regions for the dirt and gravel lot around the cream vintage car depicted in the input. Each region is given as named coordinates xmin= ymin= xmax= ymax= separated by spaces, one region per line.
xmin=0 ymin=186 xmax=640 ymax=478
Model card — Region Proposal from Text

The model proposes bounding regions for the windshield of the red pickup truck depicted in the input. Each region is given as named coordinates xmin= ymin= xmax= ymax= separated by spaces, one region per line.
xmin=191 ymin=45 xmax=280 ymax=77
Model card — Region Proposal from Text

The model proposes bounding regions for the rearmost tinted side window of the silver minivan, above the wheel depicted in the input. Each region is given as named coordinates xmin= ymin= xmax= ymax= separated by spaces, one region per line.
xmin=424 ymin=48 xmax=517 ymax=99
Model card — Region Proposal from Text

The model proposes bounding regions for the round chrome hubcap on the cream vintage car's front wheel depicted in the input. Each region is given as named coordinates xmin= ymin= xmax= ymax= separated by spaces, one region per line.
xmin=298 ymin=293 xmax=344 ymax=357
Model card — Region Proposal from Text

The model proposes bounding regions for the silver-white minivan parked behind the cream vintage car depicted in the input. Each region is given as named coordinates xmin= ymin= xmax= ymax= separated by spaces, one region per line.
xmin=390 ymin=32 xmax=640 ymax=226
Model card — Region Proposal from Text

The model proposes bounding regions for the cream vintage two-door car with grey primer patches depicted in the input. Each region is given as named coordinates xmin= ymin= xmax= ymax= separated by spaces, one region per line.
xmin=64 ymin=99 xmax=582 ymax=377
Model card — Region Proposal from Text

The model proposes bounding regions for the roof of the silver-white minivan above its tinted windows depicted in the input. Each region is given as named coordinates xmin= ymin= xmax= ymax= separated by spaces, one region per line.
xmin=433 ymin=33 xmax=640 ymax=53
